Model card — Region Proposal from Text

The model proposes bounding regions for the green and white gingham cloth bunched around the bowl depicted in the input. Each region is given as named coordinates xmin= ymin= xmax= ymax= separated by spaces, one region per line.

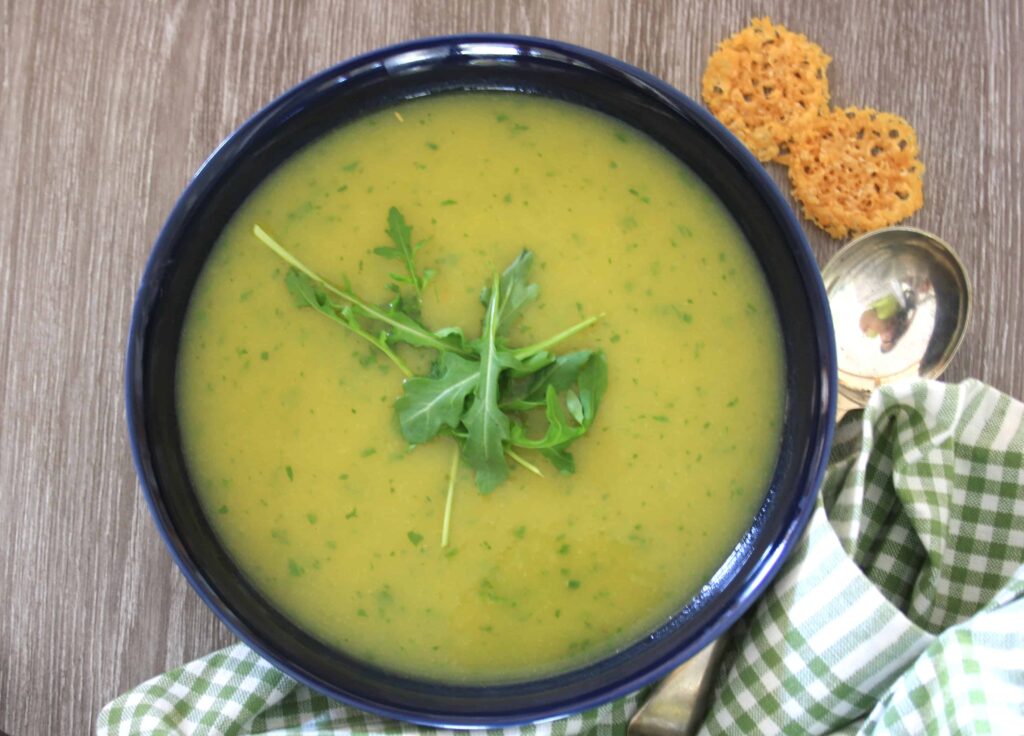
xmin=97 ymin=381 xmax=1024 ymax=736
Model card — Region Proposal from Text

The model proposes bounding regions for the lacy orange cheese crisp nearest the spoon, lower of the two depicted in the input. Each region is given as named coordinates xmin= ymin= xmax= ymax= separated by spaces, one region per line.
xmin=790 ymin=107 xmax=925 ymax=239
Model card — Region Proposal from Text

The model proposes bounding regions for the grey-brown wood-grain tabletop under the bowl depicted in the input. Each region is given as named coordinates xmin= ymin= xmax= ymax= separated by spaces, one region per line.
xmin=0 ymin=0 xmax=1024 ymax=736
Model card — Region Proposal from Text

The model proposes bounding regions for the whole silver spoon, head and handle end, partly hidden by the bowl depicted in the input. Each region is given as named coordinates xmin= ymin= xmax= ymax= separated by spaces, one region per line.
xmin=629 ymin=227 xmax=972 ymax=736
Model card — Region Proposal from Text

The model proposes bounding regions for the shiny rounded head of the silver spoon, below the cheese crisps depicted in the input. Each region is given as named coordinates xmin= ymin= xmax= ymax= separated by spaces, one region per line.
xmin=821 ymin=227 xmax=972 ymax=406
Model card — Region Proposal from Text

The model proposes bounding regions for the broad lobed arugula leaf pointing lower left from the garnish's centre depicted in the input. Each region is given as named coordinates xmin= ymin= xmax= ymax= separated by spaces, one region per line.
xmin=394 ymin=353 xmax=480 ymax=444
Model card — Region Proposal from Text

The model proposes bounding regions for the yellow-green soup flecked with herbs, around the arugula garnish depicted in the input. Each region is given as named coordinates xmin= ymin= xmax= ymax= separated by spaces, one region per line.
xmin=178 ymin=93 xmax=784 ymax=683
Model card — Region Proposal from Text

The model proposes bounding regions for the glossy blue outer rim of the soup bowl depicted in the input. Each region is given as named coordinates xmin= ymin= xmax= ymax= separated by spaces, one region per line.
xmin=125 ymin=34 xmax=838 ymax=729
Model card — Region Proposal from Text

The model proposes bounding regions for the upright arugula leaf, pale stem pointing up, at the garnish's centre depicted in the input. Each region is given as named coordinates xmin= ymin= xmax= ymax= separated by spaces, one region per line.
xmin=463 ymin=275 xmax=509 ymax=493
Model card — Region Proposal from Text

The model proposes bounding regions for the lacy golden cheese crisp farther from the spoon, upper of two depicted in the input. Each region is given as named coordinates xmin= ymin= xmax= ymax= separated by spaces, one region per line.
xmin=701 ymin=17 xmax=831 ymax=164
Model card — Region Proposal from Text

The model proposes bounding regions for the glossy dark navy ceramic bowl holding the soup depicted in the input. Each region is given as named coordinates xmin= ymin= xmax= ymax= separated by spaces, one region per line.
xmin=126 ymin=36 xmax=836 ymax=727
